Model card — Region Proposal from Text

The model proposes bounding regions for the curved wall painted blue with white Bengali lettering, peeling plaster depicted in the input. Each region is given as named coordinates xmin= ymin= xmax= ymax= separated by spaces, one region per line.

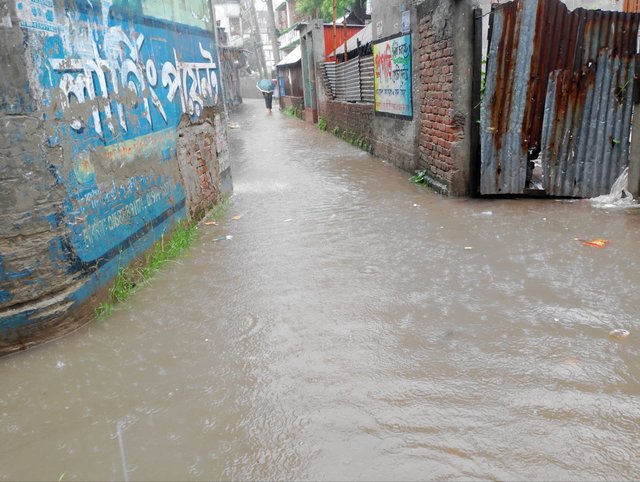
xmin=0 ymin=0 xmax=231 ymax=354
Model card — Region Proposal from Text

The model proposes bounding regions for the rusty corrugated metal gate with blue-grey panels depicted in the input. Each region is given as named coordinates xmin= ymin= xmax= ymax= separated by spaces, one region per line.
xmin=480 ymin=0 xmax=640 ymax=197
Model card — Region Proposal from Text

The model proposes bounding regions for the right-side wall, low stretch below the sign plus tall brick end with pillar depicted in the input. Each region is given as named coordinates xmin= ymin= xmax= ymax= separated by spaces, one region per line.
xmin=318 ymin=0 xmax=481 ymax=188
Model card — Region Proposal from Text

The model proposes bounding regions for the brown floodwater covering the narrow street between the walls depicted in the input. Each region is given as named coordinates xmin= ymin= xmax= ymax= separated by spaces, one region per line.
xmin=0 ymin=101 xmax=640 ymax=480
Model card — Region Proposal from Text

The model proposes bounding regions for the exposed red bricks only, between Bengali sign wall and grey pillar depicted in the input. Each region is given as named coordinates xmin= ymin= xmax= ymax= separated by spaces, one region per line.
xmin=418 ymin=6 xmax=463 ymax=192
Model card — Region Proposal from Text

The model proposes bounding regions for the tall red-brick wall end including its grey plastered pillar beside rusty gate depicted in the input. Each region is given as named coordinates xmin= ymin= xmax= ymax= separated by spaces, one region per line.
xmin=415 ymin=0 xmax=482 ymax=196
